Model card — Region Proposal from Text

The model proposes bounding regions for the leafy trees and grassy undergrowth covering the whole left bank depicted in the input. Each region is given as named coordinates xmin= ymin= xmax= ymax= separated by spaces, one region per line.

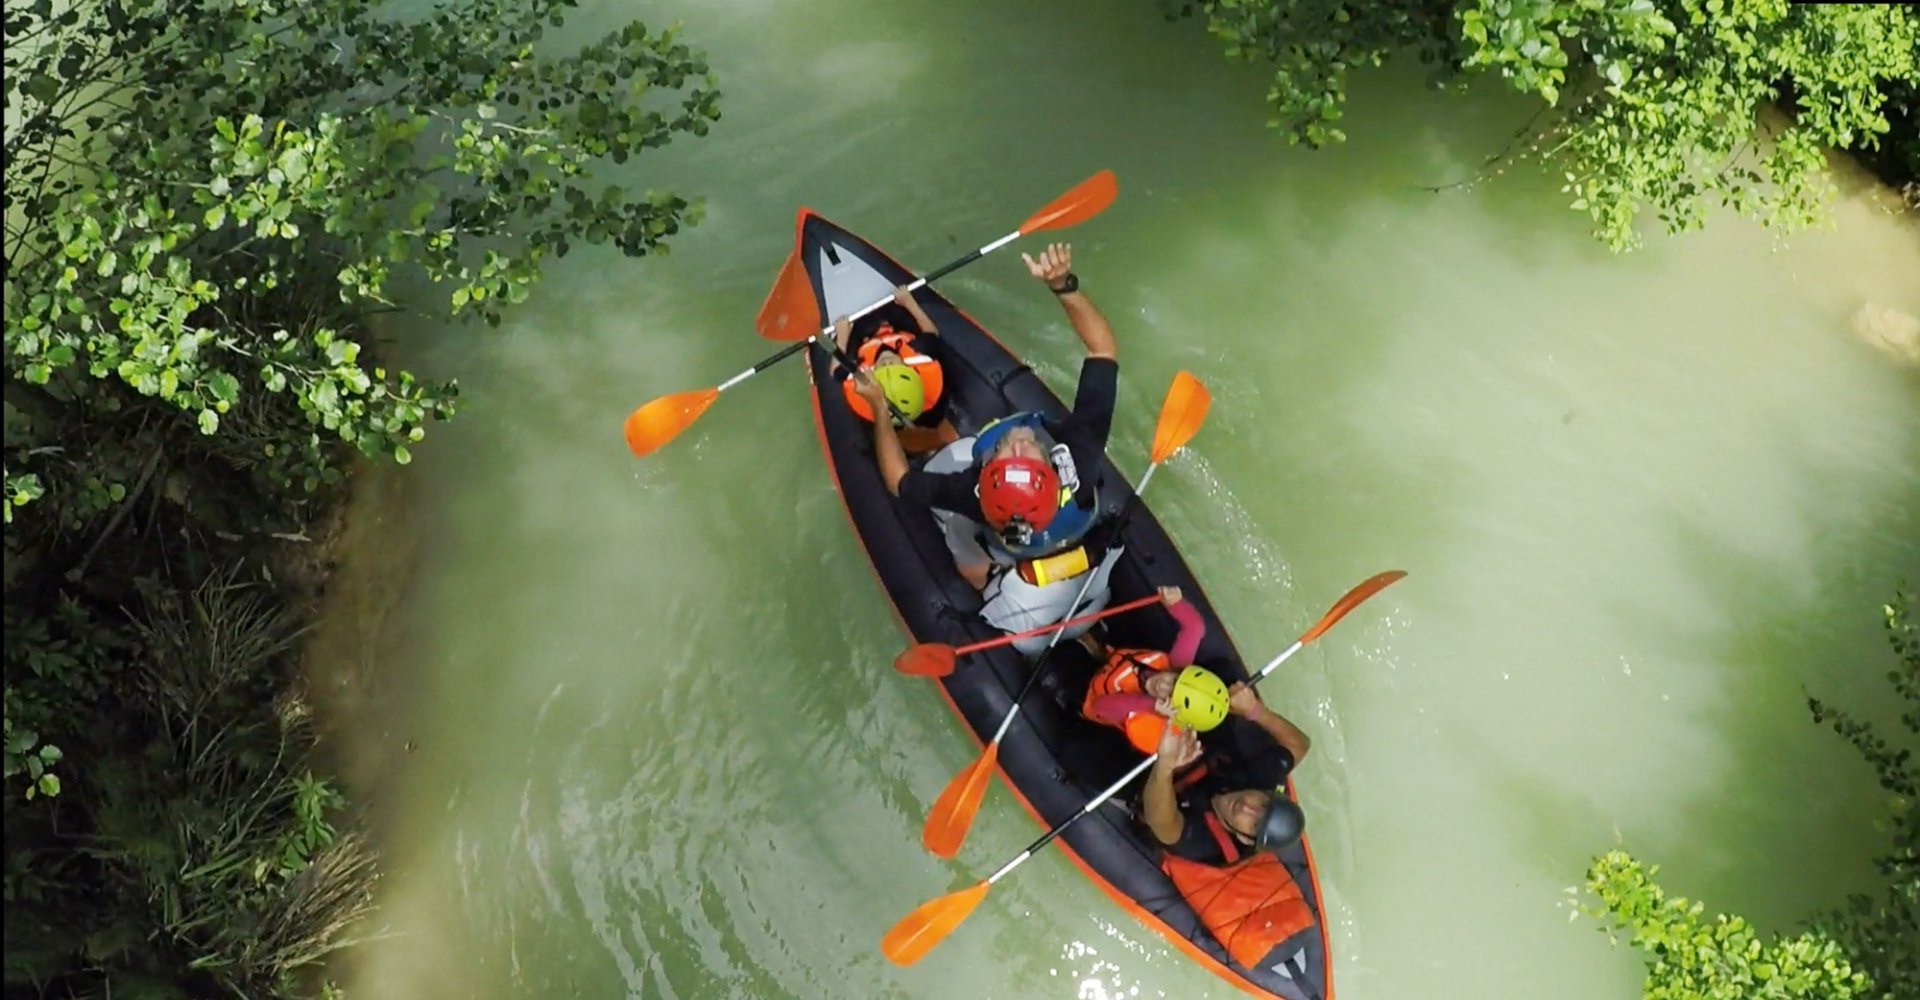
xmin=0 ymin=0 xmax=718 ymax=998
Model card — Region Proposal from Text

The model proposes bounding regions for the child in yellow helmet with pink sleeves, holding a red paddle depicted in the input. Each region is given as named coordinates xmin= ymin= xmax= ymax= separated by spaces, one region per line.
xmin=1079 ymin=587 xmax=1231 ymax=754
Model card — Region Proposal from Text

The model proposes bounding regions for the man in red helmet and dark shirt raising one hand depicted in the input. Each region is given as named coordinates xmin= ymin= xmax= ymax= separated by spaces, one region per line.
xmin=854 ymin=244 xmax=1119 ymax=589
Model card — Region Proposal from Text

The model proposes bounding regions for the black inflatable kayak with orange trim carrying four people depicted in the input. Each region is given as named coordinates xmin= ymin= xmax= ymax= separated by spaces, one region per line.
xmin=797 ymin=209 xmax=1332 ymax=1000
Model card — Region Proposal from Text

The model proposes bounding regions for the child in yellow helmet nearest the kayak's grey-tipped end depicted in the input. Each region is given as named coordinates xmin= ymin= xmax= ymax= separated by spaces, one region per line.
xmin=831 ymin=284 xmax=958 ymax=455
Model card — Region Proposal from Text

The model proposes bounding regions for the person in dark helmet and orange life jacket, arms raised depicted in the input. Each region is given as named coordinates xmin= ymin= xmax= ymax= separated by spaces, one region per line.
xmin=1140 ymin=683 xmax=1319 ymax=981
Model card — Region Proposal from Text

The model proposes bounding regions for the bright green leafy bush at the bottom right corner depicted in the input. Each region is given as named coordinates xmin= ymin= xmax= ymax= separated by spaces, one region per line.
xmin=1580 ymin=850 xmax=1874 ymax=1000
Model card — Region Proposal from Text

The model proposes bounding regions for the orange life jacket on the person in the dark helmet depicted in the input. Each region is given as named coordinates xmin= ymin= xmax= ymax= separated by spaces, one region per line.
xmin=1160 ymin=810 xmax=1315 ymax=971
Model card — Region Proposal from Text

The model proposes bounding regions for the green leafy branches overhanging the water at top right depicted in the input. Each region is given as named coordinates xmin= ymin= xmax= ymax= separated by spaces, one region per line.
xmin=1181 ymin=0 xmax=1920 ymax=250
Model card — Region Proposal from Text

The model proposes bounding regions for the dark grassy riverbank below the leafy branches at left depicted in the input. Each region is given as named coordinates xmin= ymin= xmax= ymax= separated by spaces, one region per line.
xmin=6 ymin=416 xmax=376 ymax=996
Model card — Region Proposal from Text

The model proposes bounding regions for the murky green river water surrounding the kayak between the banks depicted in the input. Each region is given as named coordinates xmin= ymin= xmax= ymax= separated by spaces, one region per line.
xmin=313 ymin=0 xmax=1920 ymax=1000
